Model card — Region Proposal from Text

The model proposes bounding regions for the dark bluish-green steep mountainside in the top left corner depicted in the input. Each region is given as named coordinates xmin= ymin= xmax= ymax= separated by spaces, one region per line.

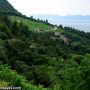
xmin=0 ymin=0 xmax=20 ymax=14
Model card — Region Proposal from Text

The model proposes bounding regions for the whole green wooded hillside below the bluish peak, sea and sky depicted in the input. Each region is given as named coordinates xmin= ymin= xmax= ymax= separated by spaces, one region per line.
xmin=0 ymin=0 xmax=90 ymax=90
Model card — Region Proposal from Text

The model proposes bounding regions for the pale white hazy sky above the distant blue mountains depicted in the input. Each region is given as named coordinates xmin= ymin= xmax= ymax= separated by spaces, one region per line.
xmin=8 ymin=0 xmax=90 ymax=15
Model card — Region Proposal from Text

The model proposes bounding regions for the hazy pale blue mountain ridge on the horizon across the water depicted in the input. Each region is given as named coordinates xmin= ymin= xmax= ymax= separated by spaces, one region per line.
xmin=32 ymin=14 xmax=90 ymax=23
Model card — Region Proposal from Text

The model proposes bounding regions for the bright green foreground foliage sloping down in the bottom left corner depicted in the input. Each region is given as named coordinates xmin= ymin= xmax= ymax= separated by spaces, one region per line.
xmin=0 ymin=64 xmax=46 ymax=90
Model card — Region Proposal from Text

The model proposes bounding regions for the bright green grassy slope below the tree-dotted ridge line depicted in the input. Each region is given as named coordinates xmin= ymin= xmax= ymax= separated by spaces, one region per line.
xmin=10 ymin=16 xmax=63 ymax=32
